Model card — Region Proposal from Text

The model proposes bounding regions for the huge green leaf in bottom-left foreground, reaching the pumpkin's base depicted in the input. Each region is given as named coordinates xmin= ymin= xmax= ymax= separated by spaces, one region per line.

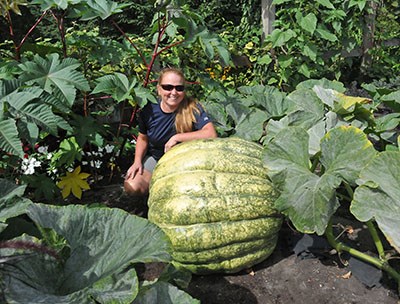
xmin=2 ymin=204 xmax=170 ymax=304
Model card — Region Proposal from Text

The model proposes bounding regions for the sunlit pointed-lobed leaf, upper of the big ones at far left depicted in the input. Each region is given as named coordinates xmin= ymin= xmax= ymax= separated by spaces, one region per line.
xmin=20 ymin=54 xmax=90 ymax=108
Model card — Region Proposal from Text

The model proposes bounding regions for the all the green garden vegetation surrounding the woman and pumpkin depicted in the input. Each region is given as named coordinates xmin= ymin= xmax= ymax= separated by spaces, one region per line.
xmin=0 ymin=0 xmax=400 ymax=303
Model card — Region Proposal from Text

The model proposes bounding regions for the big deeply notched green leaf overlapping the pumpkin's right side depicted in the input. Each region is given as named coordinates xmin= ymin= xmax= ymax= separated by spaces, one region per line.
xmin=264 ymin=127 xmax=376 ymax=235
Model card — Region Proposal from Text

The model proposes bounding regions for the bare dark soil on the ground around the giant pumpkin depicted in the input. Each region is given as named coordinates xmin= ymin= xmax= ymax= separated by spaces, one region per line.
xmin=76 ymin=185 xmax=400 ymax=304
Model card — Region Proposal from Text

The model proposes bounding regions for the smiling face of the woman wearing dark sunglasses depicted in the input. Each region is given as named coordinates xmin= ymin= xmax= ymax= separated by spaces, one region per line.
xmin=157 ymin=72 xmax=185 ymax=113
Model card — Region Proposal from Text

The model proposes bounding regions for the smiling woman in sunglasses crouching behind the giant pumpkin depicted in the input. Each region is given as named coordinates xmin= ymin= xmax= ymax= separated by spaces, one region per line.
xmin=124 ymin=68 xmax=217 ymax=195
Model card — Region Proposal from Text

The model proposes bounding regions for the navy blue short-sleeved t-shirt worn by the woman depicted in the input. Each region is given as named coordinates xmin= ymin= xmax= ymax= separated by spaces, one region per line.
xmin=138 ymin=101 xmax=211 ymax=160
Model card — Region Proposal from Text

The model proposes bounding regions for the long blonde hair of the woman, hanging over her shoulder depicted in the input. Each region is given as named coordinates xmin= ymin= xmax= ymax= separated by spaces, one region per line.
xmin=158 ymin=68 xmax=200 ymax=133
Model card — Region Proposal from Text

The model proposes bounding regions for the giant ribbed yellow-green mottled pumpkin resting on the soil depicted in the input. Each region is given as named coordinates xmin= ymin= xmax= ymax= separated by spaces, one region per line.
xmin=148 ymin=138 xmax=282 ymax=274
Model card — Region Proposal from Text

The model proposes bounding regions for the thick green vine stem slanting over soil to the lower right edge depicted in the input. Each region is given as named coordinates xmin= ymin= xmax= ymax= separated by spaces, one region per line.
xmin=325 ymin=220 xmax=400 ymax=290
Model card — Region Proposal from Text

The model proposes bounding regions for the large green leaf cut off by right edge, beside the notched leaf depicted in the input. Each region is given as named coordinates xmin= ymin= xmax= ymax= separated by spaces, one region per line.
xmin=350 ymin=151 xmax=400 ymax=253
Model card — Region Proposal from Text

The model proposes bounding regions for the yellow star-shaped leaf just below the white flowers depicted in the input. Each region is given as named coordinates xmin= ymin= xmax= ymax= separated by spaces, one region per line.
xmin=57 ymin=166 xmax=90 ymax=199
